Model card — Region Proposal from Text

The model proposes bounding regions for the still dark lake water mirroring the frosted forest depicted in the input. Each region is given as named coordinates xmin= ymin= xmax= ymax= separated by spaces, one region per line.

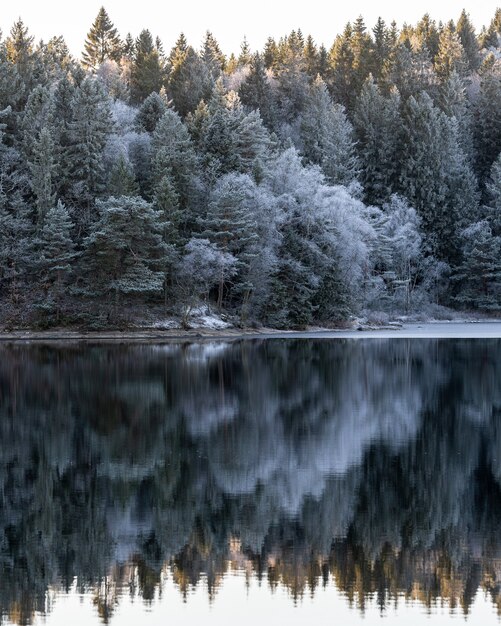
xmin=0 ymin=339 xmax=501 ymax=626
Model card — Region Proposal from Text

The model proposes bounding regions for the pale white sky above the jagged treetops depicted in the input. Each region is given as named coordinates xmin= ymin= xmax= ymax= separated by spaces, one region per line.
xmin=0 ymin=0 xmax=501 ymax=55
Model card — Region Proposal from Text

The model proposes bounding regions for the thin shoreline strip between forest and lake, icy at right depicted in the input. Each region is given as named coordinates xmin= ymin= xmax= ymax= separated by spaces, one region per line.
xmin=0 ymin=320 xmax=501 ymax=344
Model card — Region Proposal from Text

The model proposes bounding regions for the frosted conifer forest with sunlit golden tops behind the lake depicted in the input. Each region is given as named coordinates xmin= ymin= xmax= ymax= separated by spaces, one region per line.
xmin=0 ymin=8 xmax=501 ymax=328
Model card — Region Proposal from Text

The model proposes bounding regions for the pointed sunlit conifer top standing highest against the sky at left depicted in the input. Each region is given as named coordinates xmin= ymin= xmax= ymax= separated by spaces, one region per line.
xmin=82 ymin=7 xmax=123 ymax=71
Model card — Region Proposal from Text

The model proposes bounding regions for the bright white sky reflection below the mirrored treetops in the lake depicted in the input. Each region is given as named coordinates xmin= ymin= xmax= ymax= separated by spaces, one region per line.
xmin=17 ymin=575 xmax=499 ymax=626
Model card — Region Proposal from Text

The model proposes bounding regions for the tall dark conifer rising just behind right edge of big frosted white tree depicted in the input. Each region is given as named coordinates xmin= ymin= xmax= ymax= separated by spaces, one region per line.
xmin=353 ymin=77 xmax=401 ymax=206
